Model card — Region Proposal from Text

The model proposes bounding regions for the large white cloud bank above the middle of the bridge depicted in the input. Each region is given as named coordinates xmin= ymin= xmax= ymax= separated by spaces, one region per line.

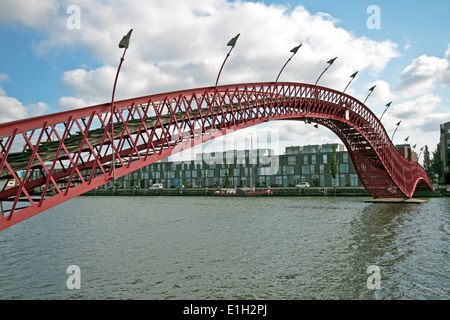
xmin=12 ymin=0 xmax=399 ymax=107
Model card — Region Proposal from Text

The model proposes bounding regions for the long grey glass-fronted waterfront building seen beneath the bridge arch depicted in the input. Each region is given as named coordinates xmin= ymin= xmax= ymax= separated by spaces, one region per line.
xmin=105 ymin=143 xmax=362 ymax=189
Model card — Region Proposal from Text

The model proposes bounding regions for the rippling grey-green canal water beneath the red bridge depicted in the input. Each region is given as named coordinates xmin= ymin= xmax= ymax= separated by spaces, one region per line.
xmin=0 ymin=196 xmax=450 ymax=300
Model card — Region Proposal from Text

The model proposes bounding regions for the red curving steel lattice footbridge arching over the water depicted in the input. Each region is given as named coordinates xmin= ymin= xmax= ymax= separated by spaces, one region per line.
xmin=0 ymin=82 xmax=431 ymax=230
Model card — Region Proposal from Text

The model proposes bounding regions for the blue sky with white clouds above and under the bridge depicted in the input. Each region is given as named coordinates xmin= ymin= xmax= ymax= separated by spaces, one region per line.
xmin=0 ymin=0 xmax=450 ymax=161
